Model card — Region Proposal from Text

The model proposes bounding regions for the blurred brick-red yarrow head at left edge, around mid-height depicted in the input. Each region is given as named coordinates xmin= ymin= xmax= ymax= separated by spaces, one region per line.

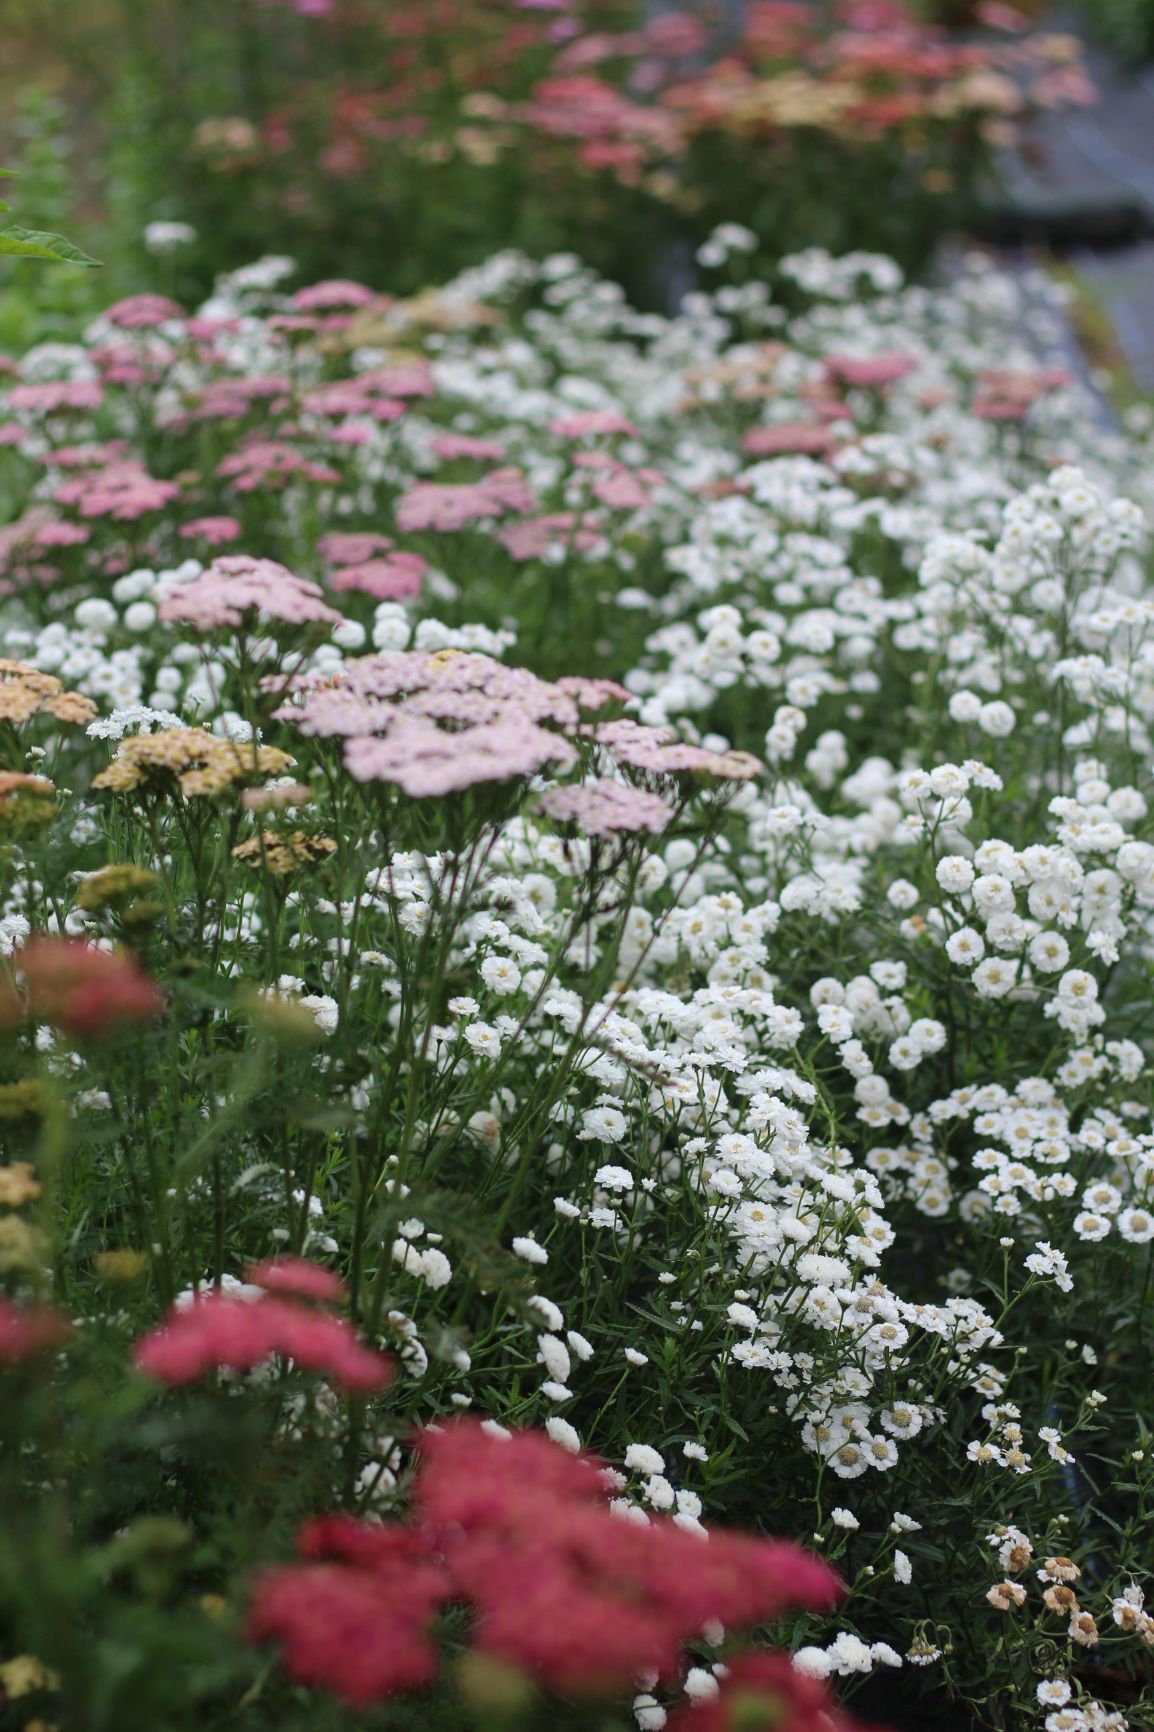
xmin=0 ymin=939 xmax=165 ymax=1039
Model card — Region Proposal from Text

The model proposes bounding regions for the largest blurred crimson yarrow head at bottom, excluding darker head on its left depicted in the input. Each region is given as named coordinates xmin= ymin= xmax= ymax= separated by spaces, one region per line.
xmin=414 ymin=1422 xmax=840 ymax=1694
